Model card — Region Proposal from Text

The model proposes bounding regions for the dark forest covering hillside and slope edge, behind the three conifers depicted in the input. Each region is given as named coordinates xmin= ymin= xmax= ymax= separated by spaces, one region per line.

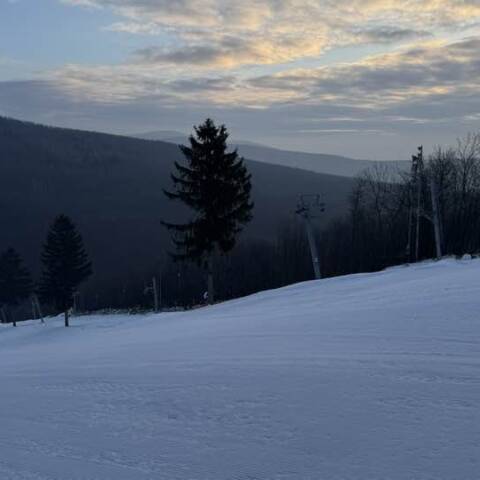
xmin=0 ymin=115 xmax=480 ymax=319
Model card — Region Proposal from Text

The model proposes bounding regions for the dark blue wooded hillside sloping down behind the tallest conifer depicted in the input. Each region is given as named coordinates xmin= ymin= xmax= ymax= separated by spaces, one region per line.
xmin=0 ymin=117 xmax=352 ymax=306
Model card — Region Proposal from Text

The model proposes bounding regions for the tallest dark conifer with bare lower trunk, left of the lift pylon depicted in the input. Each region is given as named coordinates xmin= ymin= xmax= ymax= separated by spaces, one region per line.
xmin=162 ymin=119 xmax=253 ymax=303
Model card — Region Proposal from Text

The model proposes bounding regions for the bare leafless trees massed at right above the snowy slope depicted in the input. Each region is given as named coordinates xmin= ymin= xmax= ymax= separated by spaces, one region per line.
xmin=322 ymin=134 xmax=480 ymax=275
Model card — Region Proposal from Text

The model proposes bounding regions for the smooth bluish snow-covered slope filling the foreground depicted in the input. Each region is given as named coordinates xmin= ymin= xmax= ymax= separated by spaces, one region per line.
xmin=0 ymin=260 xmax=480 ymax=480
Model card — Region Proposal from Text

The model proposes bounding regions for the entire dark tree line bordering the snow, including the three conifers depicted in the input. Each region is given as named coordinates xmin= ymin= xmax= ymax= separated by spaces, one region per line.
xmin=0 ymin=120 xmax=480 ymax=326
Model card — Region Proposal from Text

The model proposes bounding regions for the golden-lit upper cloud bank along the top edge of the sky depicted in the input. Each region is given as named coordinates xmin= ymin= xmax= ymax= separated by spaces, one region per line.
xmin=63 ymin=0 xmax=480 ymax=69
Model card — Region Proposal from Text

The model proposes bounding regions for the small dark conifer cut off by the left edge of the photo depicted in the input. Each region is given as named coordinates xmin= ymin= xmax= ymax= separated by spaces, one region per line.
xmin=0 ymin=248 xmax=33 ymax=327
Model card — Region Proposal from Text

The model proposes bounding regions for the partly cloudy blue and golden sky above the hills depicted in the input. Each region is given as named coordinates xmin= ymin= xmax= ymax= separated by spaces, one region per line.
xmin=0 ymin=0 xmax=480 ymax=160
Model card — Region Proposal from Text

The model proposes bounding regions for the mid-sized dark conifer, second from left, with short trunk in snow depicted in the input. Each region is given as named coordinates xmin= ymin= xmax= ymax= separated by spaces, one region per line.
xmin=39 ymin=215 xmax=92 ymax=327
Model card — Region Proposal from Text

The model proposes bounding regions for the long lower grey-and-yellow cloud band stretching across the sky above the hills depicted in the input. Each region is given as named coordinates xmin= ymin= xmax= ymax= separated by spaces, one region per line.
xmin=17 ymin=37 xmax=480 ymax=131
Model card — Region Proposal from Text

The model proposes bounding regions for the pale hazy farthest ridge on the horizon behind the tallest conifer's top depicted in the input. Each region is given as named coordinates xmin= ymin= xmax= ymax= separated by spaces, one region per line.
xmin=135 ymin=131 xmax=409 ymax=177
